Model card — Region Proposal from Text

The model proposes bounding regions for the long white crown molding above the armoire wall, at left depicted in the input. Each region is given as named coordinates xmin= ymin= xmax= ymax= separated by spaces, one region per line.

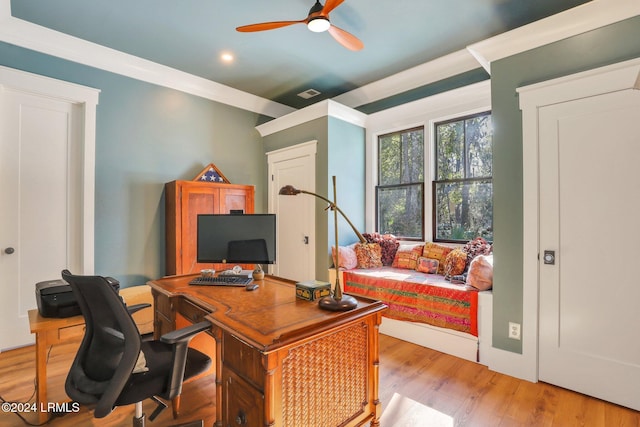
xmin=0 ymin=0 xmax=295 ymax=117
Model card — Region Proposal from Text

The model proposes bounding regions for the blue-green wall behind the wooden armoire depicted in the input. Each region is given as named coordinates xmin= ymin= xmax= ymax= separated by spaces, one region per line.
xmin=0 ymin=43 xmax=266 ymax=287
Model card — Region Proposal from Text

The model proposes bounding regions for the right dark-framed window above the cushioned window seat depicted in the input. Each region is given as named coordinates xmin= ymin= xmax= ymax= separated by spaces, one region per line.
xmin=432 ymin=112 xmax=493 ymax=242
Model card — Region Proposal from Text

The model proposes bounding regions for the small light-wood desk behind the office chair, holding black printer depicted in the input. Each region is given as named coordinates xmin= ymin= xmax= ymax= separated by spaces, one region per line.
xmin=29 ymin=286 xmax=153 ymax=423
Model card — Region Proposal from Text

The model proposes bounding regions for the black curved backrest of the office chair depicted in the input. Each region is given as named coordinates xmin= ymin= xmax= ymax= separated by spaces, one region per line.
xmin=62 ymin=270 xmax=142 ymax=418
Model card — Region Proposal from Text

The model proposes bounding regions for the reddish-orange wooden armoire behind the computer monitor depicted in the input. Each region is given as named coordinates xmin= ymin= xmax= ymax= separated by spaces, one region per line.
xmin=165 ymin=181 xmax=255 ymax=275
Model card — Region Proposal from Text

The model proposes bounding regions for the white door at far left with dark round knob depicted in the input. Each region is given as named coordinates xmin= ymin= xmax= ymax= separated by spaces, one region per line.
xmin=0 ymin=89 xmax=82 ymax=349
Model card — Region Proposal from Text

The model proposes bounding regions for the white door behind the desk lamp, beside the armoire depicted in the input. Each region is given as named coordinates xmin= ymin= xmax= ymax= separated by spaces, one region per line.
xmin=268 ymin=142 xmax=317 ymax=281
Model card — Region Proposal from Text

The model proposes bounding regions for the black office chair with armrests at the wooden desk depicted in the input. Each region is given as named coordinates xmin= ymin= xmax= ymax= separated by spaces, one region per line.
xmin=62 ymin=270 xmax=211 ymax=427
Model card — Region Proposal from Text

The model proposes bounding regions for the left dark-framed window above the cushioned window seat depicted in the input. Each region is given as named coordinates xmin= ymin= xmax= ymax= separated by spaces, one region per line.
xmin=376 ymin=127 xmax=425 ymax=240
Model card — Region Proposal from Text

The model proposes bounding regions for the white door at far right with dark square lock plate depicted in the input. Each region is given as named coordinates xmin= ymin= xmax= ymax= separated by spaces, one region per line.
xmin=539 ymin=89 xmax=640 ymax=410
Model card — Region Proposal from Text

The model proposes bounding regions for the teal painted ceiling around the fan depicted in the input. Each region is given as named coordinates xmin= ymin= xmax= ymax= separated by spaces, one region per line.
xmin=11 ymin=0 xmax=587 ymax=112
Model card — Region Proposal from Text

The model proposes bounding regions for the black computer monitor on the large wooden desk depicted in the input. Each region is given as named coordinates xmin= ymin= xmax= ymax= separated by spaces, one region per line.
xmin=197 ymin=214 xmax=276 ymax=264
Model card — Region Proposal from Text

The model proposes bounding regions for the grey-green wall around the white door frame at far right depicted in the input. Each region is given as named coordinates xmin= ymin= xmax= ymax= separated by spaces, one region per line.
xmin=491 ymin=17 xmax=640 ymax=353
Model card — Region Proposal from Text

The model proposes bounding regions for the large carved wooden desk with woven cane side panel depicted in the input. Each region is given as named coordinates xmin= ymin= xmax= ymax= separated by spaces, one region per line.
xmin=148 ymin=275 xmax=386 ymax=427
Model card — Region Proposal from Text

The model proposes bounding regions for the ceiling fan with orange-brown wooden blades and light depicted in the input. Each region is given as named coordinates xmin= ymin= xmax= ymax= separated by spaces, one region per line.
xmin=236 ymin=0 xmax=364 ymax=50
